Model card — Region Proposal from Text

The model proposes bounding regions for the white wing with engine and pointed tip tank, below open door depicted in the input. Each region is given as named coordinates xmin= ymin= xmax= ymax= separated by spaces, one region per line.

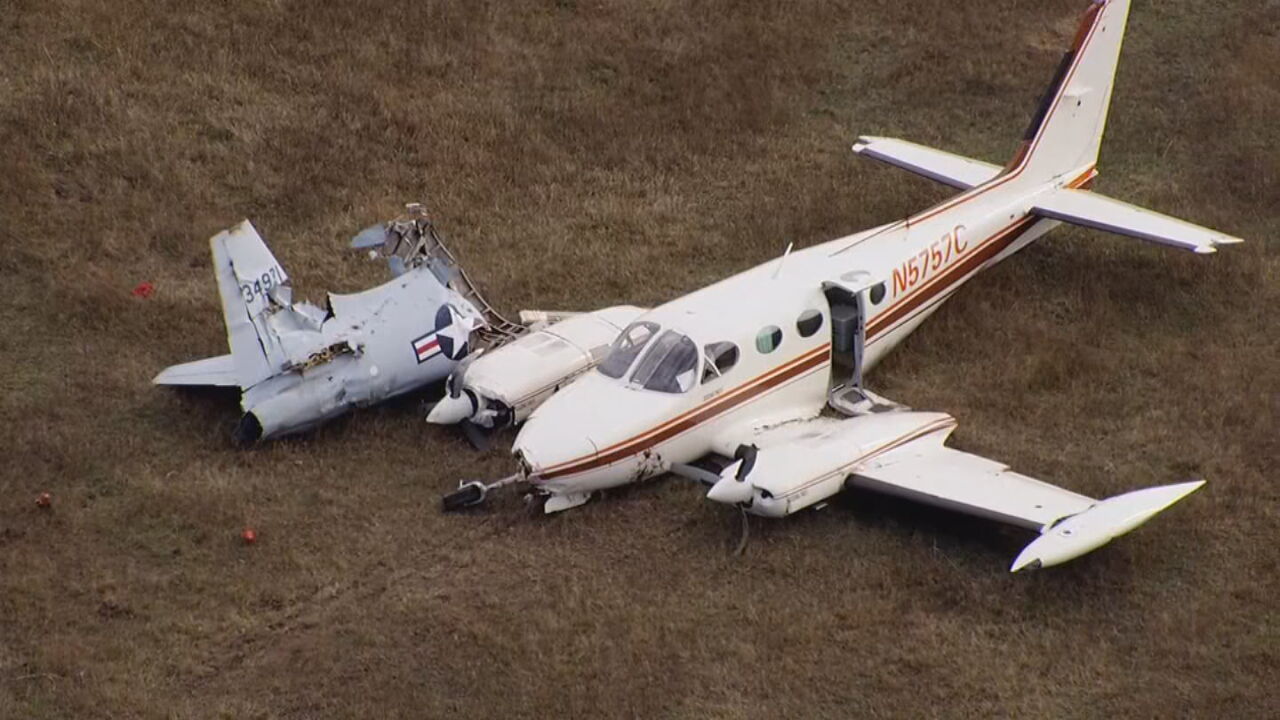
xmin=707 ymin=410 xmax=1204 ymax=571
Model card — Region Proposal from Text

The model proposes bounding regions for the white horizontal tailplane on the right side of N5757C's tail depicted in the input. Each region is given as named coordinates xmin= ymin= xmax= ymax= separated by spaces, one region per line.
xmin=1032 ymin=190 xmax=1242 ymax=254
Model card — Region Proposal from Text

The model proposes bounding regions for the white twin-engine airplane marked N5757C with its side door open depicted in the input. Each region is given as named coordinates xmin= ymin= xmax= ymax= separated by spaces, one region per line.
xmin=434 ymin=0 xmax=1239 ymax=571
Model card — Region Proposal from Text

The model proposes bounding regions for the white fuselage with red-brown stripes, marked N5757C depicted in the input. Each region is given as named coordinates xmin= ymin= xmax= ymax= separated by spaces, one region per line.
xmin=513 ymin=161 xmax=1096 ymax=495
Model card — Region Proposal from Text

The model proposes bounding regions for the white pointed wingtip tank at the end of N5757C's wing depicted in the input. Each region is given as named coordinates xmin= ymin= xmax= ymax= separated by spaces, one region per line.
xmin=1010 ymin=480 xmax=1204 ymax=573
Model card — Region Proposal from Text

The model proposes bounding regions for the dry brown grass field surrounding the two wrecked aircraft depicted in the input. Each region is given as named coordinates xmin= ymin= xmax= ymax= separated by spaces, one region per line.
xmin=0 ymin=0 xmax=1280 ymax=717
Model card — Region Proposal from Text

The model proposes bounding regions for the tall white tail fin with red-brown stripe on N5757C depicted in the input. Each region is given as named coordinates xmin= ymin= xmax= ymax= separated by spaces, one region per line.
xmin=1006 ymin=0 xmax=1129 ymax=182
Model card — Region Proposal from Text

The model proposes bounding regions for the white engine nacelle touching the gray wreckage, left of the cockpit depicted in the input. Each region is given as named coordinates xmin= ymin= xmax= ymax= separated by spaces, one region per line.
xmin=426 ymin=305 xmax=644 ymax=429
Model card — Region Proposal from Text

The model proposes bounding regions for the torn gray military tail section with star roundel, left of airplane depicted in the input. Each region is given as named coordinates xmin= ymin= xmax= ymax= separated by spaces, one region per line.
xmin=152 ymin=205 xmax=524 ymax=445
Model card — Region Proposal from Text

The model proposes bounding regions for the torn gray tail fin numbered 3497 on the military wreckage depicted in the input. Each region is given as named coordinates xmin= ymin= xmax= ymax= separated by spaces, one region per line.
xmin=209 ymin=220 xmax=289 ymax=388
